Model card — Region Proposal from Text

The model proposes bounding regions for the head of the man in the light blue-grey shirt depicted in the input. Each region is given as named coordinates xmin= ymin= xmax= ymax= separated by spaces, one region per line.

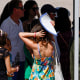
xmin=9 ymin=0 xmax=24 ymax=18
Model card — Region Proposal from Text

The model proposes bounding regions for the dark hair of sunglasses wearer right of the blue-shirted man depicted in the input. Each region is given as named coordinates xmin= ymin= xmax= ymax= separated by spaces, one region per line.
xmin=24 ymin=0 xmax=37 ymax=20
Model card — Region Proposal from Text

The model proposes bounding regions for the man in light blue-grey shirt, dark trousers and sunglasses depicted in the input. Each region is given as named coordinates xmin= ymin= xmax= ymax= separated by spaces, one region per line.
xmin=1 ymin=0 xmax=25 ymax=80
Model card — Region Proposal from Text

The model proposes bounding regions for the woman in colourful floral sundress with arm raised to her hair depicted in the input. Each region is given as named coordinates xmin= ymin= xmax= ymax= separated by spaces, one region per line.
xmin=19 ymin=24 xmax=55 ymax=80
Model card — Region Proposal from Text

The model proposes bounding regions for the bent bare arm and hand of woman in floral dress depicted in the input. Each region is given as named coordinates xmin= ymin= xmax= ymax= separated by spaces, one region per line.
xmin=19 ymin=30 xmax=45 ymax=49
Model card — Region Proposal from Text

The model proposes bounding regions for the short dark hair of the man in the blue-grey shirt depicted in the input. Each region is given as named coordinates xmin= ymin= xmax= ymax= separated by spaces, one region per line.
xmin=9 ymin=0 xmax=22 ymax=15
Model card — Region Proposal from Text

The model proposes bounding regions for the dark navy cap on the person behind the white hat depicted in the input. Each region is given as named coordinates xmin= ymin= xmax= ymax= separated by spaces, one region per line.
xmin=41 ymin=4 xmax=56 ymax=14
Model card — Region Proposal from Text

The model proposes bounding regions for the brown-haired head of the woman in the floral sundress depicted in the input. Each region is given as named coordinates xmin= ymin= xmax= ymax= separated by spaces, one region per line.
xmin=31 ymin=23 xmax=52 ymax=42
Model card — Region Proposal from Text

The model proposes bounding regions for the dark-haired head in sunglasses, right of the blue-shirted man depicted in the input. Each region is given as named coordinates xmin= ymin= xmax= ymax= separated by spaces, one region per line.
xmin=24 ymin=0 xmax=38 ymax=19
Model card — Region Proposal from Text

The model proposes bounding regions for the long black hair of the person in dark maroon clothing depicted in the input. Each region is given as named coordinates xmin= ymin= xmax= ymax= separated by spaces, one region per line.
xmin=55 ymin=7 xmax=71 ymax=32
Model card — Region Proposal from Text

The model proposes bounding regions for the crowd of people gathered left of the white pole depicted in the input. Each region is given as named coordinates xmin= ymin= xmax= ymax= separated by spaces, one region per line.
xmin=0 ymin=0 xmax=80 ymax=80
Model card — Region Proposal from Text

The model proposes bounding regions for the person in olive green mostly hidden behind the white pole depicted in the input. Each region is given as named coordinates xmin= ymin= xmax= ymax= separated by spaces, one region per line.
xmin=70 ymin=17 xmax=80 ymax=80
